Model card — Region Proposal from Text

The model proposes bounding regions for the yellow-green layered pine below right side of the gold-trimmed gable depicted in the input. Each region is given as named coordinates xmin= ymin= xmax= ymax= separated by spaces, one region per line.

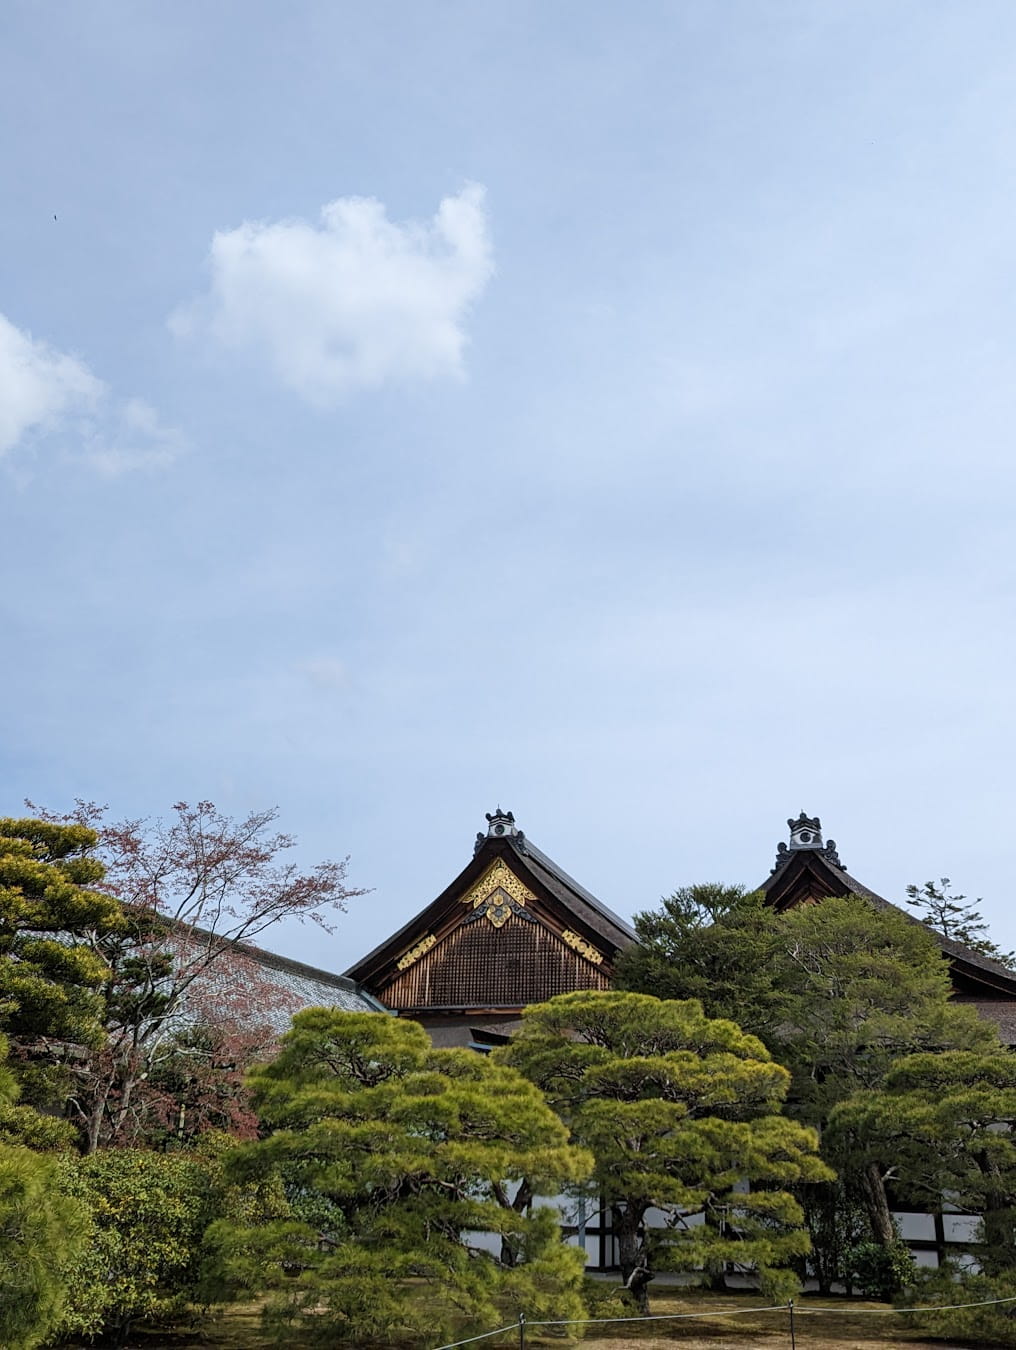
xmin=497 ymin=991 xmax=831 ymax=1312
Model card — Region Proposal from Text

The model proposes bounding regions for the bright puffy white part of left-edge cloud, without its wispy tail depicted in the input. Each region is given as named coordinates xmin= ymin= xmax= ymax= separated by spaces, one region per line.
xmin=0 ymin=315 xmax=105 ymax=454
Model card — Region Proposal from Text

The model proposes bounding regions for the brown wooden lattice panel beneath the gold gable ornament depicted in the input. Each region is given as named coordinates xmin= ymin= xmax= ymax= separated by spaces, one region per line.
xmin=378 ymin=915 xmax=610 ymax=1008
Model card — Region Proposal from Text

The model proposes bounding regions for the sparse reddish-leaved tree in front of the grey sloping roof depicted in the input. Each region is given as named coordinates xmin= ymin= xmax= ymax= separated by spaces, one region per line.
xmin=32 ymin=802 xmax=363 ymax=1153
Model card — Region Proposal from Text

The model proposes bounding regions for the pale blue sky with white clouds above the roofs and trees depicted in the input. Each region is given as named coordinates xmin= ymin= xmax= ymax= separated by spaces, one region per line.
xmin=0 ymin=0 xmax=1016 ymax=969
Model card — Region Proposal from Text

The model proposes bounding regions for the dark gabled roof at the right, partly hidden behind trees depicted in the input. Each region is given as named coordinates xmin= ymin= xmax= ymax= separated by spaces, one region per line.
xmin=760 ymin=811 xmax=1016 ymax=1004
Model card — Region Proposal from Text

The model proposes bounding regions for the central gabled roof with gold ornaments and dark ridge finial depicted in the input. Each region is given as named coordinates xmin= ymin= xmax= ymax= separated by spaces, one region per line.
xmin=345 ymin=809 xmax=636 ymax=1011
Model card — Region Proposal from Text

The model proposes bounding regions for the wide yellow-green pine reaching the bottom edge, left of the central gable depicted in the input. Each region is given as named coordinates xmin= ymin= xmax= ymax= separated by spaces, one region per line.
xmin=210 ymin=1008 xmax=591 ymax=1343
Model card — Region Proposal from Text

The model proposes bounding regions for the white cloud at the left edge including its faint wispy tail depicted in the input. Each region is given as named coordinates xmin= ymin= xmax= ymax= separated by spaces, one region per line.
xmin=0 ymin=315 xmax=184 ymax=477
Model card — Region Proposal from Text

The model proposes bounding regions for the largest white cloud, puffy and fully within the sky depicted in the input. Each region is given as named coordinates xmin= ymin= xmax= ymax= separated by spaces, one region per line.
xmin=170 ymin=185 xmax=494 ymax=405
